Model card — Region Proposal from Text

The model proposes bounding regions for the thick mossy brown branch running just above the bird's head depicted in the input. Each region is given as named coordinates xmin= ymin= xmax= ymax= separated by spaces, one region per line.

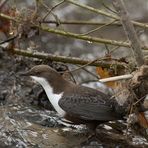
xmin=4 ymin=48 xmax=127 ymax=69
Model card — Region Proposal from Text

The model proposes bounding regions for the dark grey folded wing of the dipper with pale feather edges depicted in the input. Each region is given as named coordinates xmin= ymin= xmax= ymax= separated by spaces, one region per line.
xmin=59 ymin=87 xmax=122 ymax=121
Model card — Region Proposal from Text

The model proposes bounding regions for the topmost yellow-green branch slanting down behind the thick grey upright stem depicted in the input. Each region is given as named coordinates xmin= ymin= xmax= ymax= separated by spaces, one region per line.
xmin=65 ymin=0 xmax=148 ymax=28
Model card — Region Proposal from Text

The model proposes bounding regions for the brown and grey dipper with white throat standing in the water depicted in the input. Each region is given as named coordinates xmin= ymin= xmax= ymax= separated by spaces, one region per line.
xmin=23 ymin=65 xmax=125 ymax=132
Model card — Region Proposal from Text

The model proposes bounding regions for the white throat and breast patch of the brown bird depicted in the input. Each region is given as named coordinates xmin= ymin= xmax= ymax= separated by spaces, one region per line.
xmin=31 ymin=76 xmax=66 ymax=116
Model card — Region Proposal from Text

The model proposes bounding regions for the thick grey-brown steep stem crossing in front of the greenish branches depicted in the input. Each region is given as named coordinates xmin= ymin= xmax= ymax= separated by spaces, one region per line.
xmin=113 ymin=0 xmax=144 ymax=66
